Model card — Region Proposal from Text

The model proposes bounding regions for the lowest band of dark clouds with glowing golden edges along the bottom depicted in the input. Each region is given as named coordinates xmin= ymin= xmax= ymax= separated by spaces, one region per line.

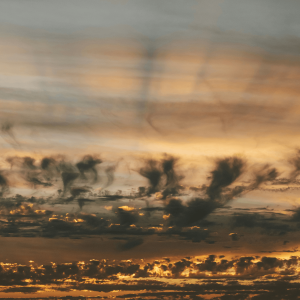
xmin=0 ymin=254 xmax=299 ymax=299
